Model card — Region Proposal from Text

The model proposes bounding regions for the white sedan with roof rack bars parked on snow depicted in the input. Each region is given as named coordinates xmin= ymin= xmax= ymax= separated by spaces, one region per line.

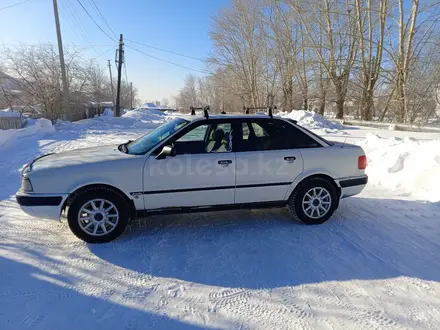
xmin=16 ymin=115 xmax=368 ymax=243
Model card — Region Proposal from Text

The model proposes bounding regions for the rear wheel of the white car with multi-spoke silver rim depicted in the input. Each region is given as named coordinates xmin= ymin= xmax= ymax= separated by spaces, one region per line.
xmin=288 ymin=178 xmax=338 ymax=225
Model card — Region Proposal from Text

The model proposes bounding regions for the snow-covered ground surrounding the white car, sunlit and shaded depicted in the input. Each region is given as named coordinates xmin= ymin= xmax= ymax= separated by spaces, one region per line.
xmin=0 ymin=111 xmax=440 ymax=330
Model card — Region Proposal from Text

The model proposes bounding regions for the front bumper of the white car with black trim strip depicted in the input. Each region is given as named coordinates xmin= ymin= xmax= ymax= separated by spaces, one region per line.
xmin=15 ymin=191 xmax=68 ymax=220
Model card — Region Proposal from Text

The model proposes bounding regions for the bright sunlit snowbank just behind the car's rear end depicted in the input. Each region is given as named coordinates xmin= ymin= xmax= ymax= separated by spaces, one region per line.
xmin=357 ymin=133 xmax=440 ymax=202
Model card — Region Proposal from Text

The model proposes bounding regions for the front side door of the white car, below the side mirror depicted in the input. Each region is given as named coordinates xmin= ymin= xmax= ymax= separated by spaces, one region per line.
xmin=143 ymin=120 xmax=236 ymax=210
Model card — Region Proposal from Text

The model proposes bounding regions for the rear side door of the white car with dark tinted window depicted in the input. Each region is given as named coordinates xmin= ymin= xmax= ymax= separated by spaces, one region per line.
xmin=235 ymin=119 xmax=303 ymax=203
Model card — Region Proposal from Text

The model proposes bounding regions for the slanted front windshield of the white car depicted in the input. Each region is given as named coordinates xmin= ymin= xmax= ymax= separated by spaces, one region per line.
xmin=126 ymin=118 xmax=189 ymax=155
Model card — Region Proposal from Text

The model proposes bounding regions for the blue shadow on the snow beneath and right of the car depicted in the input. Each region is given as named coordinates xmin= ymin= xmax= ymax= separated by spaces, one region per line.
xmin=89 ymin=198 xmax=440 ymax=288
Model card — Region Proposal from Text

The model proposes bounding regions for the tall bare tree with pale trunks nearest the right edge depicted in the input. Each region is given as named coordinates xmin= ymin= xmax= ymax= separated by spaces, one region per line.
xmin=383 ymin=0 xmax=440 ymax=123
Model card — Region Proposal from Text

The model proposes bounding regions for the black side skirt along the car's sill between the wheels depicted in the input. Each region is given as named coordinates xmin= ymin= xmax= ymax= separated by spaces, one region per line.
xmin=136 ymin=201 xmax=287 ymax=218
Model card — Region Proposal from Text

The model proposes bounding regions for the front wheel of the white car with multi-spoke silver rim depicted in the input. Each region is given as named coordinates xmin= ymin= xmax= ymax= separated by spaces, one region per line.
xmin=67 ymin=188 xmax=130 ymax=243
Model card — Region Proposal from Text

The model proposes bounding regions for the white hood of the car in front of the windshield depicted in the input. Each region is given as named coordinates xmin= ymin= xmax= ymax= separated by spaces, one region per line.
xmin=30 ymin=145 xmax=133 ymax=171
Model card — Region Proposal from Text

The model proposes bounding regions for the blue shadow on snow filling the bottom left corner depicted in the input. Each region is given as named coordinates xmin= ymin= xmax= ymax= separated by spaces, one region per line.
xmin=0 ymin=256 xmax=207 ymax=330
